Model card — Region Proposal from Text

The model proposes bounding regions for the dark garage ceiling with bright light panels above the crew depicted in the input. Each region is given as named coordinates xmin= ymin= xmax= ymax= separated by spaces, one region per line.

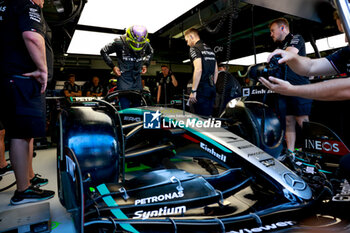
xmin=44 ymin=0 xmax=338 ymax=68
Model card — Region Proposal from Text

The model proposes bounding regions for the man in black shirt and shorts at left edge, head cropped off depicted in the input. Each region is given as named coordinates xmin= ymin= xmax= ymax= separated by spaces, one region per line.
xmin=0 ymin=0 xmax=55 ymax=205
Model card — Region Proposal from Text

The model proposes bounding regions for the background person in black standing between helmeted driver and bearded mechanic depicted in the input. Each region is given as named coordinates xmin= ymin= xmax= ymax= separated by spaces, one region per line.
xmin=157 ymin=65 xmax=177 ymax=104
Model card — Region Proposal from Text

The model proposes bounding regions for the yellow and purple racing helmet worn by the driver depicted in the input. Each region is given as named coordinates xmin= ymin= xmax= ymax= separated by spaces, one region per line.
xmin=126 ymin=25 xmax=149 ymax=51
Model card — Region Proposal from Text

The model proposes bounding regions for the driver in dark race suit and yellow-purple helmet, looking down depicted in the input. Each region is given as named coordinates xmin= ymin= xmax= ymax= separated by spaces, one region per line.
xmin=100 ymin=25 xmax=153 ymax=109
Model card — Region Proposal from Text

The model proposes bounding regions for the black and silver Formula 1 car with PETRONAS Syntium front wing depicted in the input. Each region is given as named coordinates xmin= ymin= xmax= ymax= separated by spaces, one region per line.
xmin=57 ymin=92 xmax=344 ymax=233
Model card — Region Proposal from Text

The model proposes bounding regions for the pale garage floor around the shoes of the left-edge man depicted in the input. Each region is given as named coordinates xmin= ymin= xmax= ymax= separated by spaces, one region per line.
xmin=0 ymin=148 xmax=76 ymax=233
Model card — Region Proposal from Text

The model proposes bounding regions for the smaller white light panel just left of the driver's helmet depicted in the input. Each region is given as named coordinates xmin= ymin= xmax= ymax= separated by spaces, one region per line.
xmin=67 ymin=30 xmax=120 ymax=55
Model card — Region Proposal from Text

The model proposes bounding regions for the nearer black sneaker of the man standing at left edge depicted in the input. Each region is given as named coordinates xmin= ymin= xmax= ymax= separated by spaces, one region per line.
xmin=11 ymin=185 xmax=55 ymax=205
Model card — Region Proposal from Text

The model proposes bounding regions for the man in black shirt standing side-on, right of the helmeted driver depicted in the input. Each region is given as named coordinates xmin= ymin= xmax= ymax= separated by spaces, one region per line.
xmin=185 ymin=28 xmax=218 ymax=116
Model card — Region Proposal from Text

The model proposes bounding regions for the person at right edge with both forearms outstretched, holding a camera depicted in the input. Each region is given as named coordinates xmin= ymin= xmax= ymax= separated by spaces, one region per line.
xmin=259 ymin=10 xmax=350 ymax=181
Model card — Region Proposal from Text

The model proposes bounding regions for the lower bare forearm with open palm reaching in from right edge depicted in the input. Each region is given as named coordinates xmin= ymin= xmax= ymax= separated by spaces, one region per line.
xmin=259 ymin=77 xmax=350 ymax=101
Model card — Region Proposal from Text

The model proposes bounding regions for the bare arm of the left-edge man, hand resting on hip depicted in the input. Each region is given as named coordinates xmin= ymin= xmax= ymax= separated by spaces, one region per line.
xmin=22 ymin=31 xmax=48 ymax=93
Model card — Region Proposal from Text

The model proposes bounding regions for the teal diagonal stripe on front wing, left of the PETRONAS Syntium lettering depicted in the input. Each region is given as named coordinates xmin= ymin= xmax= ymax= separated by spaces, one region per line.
xmin=97 ymin=184 xmax=139 ymax=233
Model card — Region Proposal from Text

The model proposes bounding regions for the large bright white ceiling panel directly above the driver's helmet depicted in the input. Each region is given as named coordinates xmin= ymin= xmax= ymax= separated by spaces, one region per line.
xmin=78 ymin=0 xmax=203 ymax=33
